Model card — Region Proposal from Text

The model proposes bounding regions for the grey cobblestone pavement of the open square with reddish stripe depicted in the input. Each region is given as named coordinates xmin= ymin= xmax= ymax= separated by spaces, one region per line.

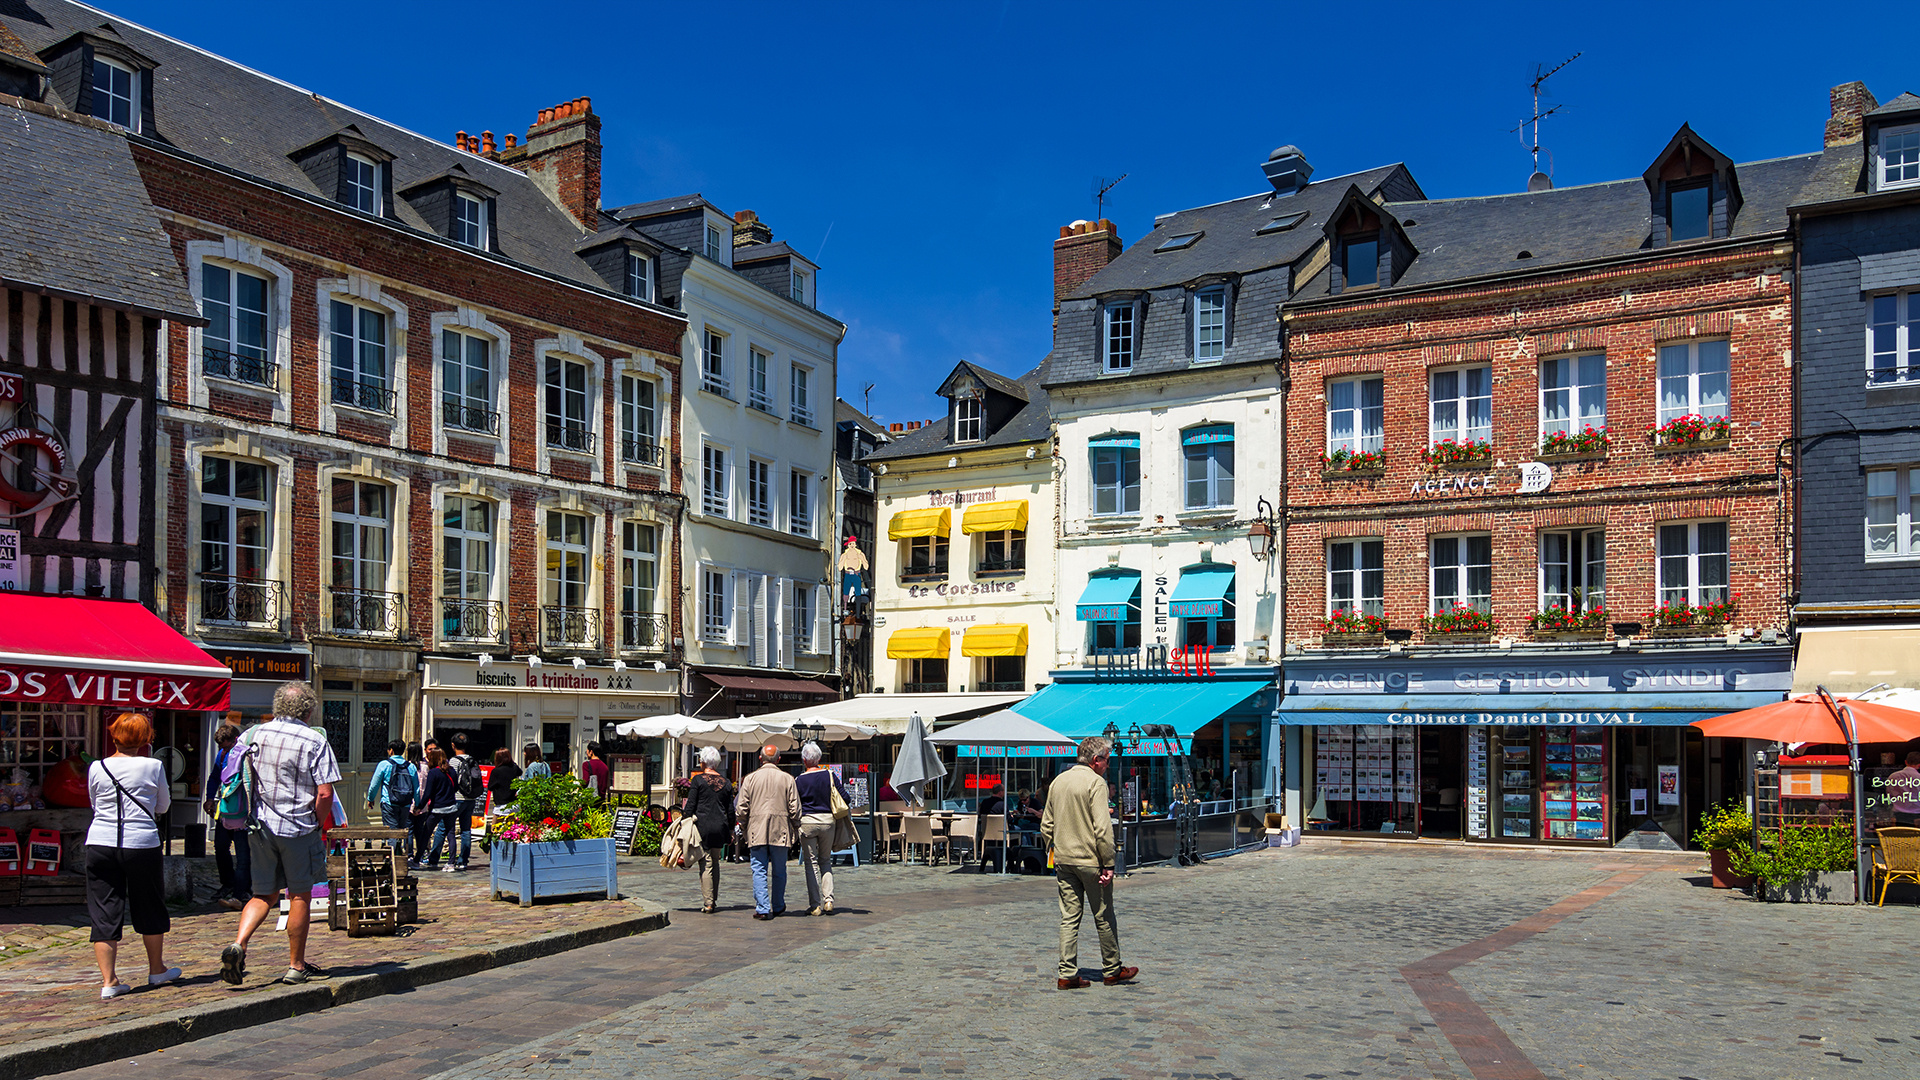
xmin=33 ymin=842 xmax=1920 ymax=1080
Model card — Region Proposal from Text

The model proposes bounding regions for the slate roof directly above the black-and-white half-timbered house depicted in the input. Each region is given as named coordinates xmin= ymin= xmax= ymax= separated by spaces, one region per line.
xmin=0 ymin=99 xmax=204 ymax=325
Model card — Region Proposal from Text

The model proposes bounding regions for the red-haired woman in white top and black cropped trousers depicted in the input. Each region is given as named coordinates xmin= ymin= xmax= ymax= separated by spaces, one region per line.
xmin=86 ymin=713 xmax=180 ymax=1001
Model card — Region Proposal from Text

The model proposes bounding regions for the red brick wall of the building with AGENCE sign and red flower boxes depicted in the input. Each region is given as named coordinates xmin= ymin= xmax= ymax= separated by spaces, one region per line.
xmin=1284 ymin=244 xmax=1791 ymax=642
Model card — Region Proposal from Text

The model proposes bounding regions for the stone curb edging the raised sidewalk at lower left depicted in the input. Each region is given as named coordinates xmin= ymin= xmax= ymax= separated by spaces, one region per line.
xmin=0 ymin=901 xmax=668 ymax=1080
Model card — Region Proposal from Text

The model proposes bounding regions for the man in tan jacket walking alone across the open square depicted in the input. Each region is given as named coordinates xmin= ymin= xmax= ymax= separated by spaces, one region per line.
xmin=1041 ymin=736 xmax=1140 ymax=990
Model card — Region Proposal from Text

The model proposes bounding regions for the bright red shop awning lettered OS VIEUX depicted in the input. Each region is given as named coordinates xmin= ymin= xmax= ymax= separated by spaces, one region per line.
xmin=0 ymin=592 xmax=232 ymax=711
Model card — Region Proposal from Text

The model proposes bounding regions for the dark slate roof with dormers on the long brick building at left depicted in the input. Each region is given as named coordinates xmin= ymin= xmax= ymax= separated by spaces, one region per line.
xmin=0 ymin=0 xmax=637 ymax=292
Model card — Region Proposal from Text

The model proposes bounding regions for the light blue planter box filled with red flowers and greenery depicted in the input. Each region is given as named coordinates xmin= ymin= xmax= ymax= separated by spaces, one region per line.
xmin=488 ymin=774 xmax=620 ymax=907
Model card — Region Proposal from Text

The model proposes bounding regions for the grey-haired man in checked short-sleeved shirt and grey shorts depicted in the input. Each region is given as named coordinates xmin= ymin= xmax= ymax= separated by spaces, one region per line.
xmin=221 ymin=680 xmax=340 ymax=986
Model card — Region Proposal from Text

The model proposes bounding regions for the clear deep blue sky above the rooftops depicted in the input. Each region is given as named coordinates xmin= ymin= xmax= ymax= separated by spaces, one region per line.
xmin=106 ymin=0 xmax=1920 ymax=421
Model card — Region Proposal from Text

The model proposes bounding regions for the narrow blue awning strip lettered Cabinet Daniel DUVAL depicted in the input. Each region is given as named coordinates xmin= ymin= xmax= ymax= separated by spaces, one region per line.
xmin=1281 ymin=690 xmax=1784 ymax=726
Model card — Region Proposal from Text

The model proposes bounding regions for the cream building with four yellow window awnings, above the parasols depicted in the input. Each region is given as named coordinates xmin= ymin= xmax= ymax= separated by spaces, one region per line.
xmin=868 ymin=363 xmax=1060 ymax=694
